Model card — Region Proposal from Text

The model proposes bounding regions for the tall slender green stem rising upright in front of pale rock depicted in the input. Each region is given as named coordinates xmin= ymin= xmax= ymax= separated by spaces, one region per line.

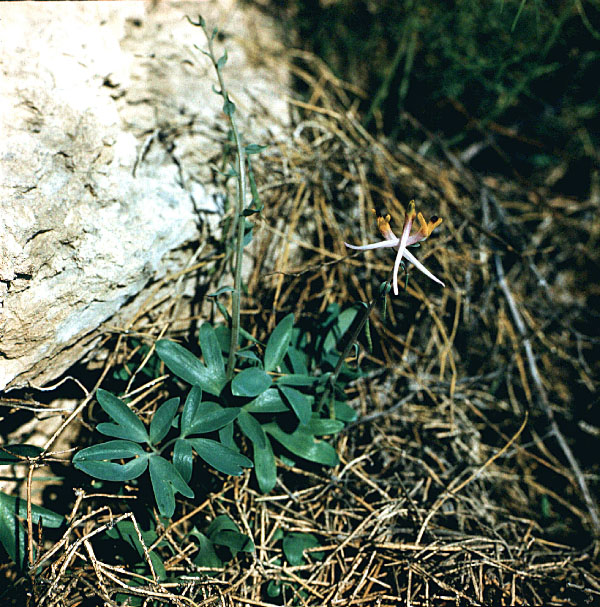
xmin=198 ymin=19 xmax=246 ymax=379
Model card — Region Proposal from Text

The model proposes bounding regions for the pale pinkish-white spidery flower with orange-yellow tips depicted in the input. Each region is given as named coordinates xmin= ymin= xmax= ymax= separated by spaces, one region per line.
xmin=344 ymin=200 xmax=446 ymax=295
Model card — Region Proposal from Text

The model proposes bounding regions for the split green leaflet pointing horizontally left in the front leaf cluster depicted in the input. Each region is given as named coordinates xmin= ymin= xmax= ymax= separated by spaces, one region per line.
xmin=73 ymin=440 xmax=148 ymax=482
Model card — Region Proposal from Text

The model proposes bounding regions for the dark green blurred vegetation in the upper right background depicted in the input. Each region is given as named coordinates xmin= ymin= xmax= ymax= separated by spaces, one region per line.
xmin=269 ymin=0 xmax=600 ymax=197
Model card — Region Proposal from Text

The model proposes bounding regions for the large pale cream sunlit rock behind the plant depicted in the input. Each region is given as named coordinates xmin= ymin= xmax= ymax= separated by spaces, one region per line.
xmin=0 ymin=0 xmax=286 ymax=390
